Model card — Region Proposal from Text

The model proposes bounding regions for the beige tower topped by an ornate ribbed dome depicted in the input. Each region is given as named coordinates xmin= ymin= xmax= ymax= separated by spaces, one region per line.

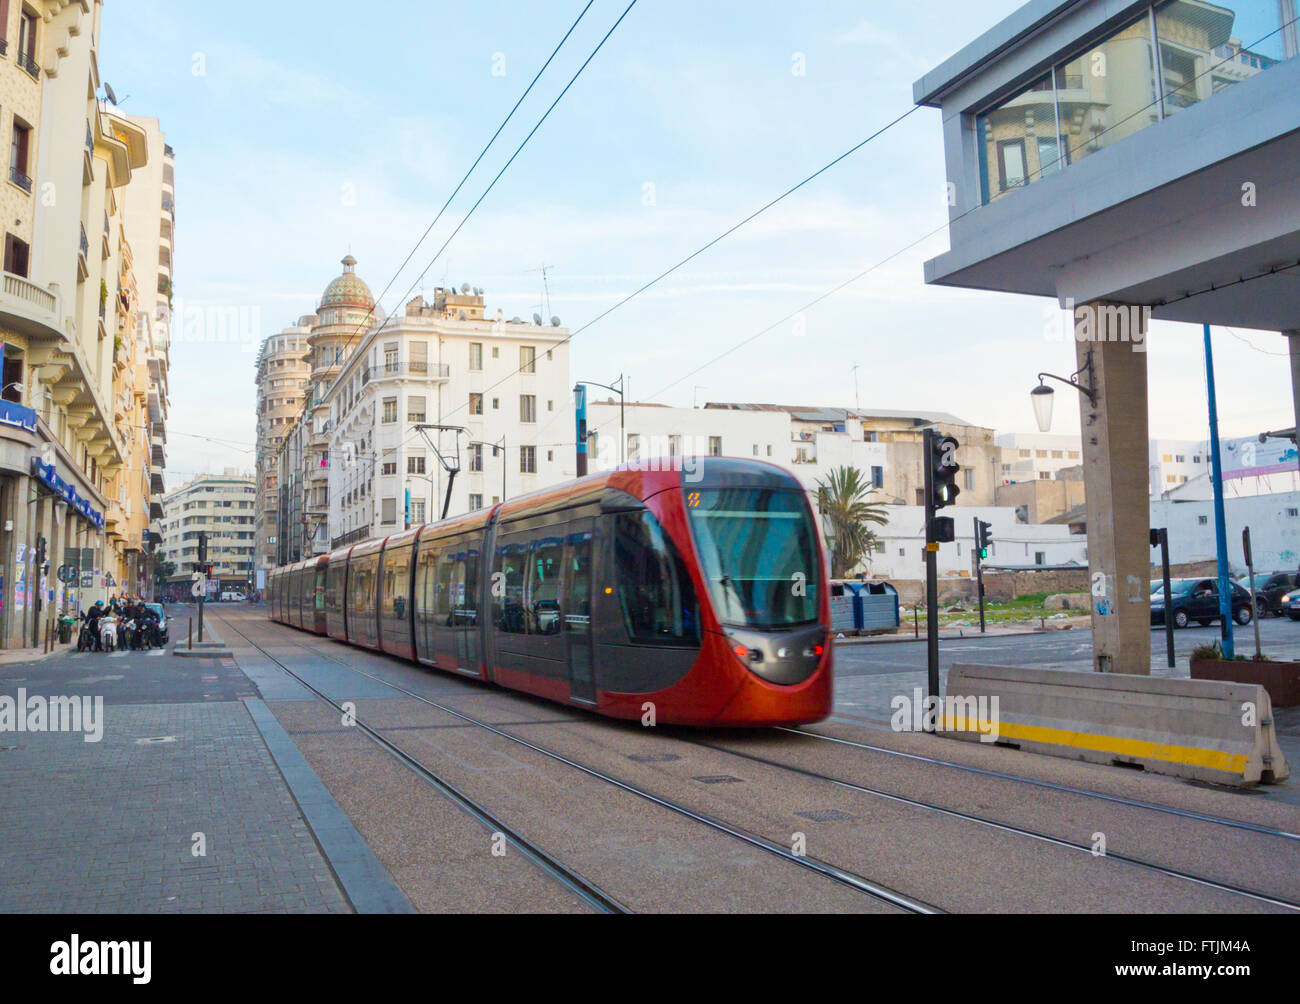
xmin=303 ymin=255 xmax=382 ymax=554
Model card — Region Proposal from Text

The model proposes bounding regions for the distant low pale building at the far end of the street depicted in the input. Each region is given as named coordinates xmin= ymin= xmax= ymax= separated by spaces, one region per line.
xmin=160 ymin=468 xmax=257 ymax=600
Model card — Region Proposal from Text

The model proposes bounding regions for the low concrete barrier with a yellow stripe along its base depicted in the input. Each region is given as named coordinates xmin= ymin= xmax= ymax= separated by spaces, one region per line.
xmin=944 ymin=666 xmax=1290 ymax=786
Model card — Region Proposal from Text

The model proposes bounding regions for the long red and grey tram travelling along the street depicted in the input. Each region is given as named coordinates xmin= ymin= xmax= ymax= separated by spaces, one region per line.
xmin=268 ymin=458 xmax=832 ymax=726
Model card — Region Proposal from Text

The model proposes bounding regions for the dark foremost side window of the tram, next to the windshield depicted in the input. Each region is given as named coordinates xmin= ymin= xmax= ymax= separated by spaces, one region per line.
xmin=614 ymin=512 xmax=699 ymax=645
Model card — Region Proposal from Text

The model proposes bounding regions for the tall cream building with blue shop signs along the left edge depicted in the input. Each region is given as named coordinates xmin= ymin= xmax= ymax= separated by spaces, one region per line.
xmin=0 ymin=0 xmax=165 ymax=648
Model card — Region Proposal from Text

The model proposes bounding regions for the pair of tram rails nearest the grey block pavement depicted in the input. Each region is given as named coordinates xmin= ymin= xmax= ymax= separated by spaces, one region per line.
xmin=212 ymin=615 xmax=943 ymax=914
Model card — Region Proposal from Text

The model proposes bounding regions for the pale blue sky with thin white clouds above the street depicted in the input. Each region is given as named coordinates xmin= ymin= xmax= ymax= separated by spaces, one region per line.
xmin=99 ymin=0 xmax=1295 ymax=488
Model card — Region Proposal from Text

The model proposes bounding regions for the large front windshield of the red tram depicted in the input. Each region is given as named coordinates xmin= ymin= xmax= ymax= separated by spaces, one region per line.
xmin=686 ymin=486 xmax=819 ymax=628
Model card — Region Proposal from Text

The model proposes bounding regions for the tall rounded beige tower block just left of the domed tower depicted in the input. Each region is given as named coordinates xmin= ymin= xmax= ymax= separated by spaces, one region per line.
xmin=255 ymin=315 xmax=316 ymax=577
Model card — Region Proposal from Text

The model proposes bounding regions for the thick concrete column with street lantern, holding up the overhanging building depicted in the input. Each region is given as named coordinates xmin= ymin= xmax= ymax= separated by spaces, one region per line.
xmin=1075 ymin=303 xmax=1151 ymax=676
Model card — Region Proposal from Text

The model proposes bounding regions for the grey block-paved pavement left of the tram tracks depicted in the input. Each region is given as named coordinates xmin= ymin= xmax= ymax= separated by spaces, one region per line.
xmin=0 ymin=642 xmax=351 ymax=913
